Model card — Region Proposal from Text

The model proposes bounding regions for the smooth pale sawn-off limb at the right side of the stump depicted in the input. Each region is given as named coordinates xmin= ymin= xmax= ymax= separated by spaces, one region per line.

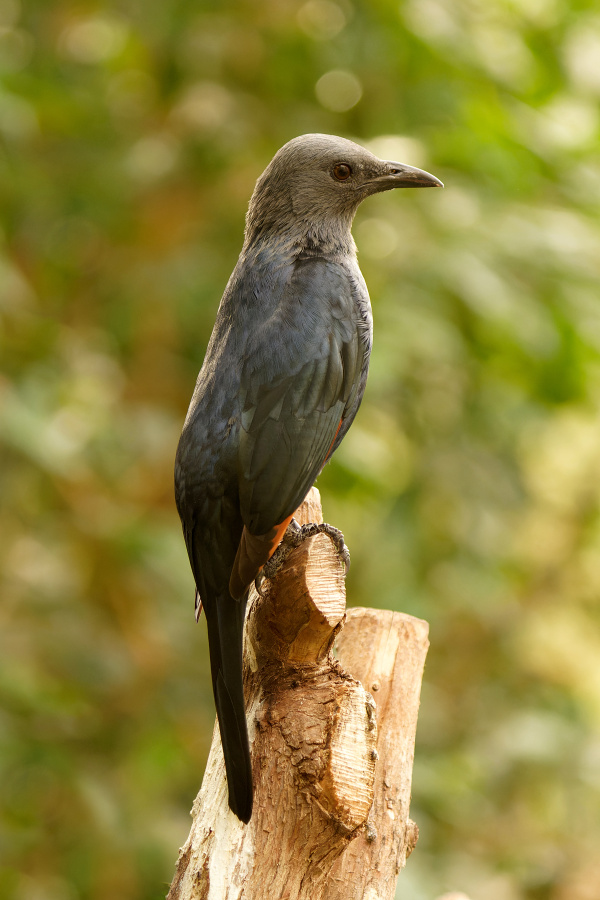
xmin=327 ymin=607 xmax=429 ymax=900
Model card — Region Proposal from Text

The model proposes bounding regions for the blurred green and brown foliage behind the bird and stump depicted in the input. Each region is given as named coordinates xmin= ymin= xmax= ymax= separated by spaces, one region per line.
xmin=0 ymin=0 xmax=600 ymax=900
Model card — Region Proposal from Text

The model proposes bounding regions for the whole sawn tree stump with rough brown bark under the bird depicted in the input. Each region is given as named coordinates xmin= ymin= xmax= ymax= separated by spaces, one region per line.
xmin=168 ymin=488 xmax=428 ymax=900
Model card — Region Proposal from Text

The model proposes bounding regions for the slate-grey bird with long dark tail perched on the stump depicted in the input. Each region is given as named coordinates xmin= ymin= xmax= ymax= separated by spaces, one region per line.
xmin=175 ymin=134 xmax=443 ymax=823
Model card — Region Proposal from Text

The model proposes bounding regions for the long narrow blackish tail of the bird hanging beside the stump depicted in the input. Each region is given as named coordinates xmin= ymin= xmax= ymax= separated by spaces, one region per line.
xmin=206 ymin=591 xmax=253 ymax=822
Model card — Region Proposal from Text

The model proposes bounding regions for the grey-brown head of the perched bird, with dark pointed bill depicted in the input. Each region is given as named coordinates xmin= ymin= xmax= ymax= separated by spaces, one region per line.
xmin=241 ymin=134 xmax=443 ymax=250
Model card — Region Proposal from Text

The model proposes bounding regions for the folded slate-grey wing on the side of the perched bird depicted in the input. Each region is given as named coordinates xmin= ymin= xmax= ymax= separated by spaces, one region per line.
xmin=238 ymin=259 xmax=367 ymax=535
